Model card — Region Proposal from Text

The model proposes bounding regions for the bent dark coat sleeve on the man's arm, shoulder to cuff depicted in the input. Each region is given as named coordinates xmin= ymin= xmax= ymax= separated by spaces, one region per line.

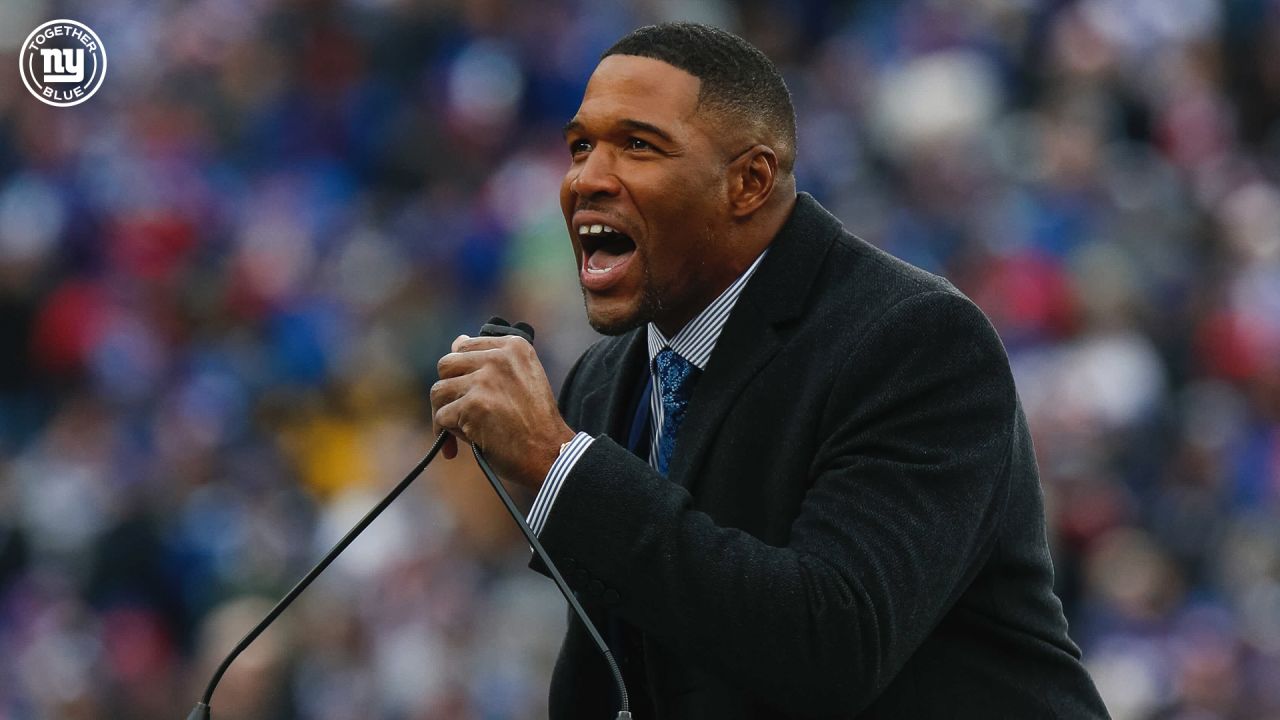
xmin=541 ymin=291 xmax=1019 ymax=715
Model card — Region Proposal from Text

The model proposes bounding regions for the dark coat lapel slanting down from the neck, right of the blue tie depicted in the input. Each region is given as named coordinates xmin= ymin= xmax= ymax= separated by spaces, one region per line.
xmin=665 ymin=193 xmax=841 ymax=491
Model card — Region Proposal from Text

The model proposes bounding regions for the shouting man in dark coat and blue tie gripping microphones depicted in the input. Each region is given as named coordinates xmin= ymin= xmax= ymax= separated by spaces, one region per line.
xmin=431 ymin=24 xmax=1106 ymax=720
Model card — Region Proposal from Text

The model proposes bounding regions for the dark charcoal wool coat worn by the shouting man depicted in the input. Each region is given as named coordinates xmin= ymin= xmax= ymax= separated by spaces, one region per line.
xmin=540 ymin=195 xmax=1106 ymax=720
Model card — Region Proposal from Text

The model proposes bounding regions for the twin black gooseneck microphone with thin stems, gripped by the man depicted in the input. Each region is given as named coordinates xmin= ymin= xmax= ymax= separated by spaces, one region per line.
xmin=187 ymin=316 xmax=631 ymax=720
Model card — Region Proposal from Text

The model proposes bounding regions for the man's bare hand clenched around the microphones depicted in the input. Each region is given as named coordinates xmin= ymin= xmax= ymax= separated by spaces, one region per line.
xmin=431 ymin=336 xmax=573 ymax=492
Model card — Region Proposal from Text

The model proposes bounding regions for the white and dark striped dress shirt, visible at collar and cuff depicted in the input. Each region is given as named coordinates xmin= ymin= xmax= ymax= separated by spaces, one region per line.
xmin=529 ymin=250 xmax=768 ymax=534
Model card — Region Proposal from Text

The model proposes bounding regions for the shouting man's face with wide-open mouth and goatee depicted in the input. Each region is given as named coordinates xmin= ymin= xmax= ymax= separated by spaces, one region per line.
xmin=561 ymin=55 xmax=741 ymax=336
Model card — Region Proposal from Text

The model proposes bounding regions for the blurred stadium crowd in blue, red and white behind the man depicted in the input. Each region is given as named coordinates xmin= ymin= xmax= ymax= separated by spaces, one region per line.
xmin=0 ymin=0 xmax=1280 ymax=720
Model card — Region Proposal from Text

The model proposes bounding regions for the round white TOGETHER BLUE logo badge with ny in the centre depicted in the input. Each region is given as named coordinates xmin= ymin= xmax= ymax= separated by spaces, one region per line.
xmin=18 ymin=20 xmax=106 ymax=108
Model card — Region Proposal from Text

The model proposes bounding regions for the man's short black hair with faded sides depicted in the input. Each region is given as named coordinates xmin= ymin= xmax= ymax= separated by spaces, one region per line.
xmin=600 ymin=23 xmax=796 ymax=172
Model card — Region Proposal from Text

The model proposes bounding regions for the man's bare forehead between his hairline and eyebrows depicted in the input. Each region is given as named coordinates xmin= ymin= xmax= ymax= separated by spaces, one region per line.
xmin=575 ymin=55 xmax=701 ymax=127
